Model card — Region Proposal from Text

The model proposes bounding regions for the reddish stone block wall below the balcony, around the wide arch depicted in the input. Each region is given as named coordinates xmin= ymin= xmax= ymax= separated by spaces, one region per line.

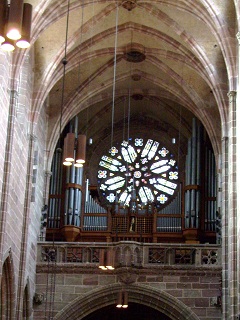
xmin=34 ymin=243 xmax=221 ymax=320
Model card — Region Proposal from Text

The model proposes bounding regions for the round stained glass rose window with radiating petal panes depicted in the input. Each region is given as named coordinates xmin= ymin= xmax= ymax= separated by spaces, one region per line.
xmin=98 ymin=138 xmax=178 ymax=207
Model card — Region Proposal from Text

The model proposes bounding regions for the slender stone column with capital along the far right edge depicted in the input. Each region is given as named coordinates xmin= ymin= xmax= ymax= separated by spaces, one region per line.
xmin=227 ymin=91 xmax=239 ymax=320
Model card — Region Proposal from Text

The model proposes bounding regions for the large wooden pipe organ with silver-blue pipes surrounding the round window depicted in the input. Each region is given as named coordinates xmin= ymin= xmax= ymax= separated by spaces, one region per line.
xmin=46 ymin=118 xmax=217 ymax=243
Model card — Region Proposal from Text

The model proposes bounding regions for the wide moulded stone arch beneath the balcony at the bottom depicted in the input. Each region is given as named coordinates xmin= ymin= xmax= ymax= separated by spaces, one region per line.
xmin=54 ymin=284 xmax=199 ymax=320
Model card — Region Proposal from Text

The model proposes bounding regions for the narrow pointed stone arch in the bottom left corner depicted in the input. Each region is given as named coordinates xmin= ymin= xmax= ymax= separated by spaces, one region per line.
xmin=0 ymin=252 xmax=15 ymax=320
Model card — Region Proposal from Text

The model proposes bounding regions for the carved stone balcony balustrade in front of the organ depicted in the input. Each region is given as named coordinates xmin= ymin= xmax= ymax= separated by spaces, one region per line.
xmin=37 ymin=241 xmax=221 ymax=271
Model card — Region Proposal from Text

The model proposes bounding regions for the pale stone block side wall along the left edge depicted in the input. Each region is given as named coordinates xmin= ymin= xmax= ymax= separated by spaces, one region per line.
xmin=0 ymin=48 xmax=47 ymax=317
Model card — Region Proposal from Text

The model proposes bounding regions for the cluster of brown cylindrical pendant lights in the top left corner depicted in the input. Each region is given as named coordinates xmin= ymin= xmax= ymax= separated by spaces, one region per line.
xmin=0 ymin=0 xmax=32 ymax=52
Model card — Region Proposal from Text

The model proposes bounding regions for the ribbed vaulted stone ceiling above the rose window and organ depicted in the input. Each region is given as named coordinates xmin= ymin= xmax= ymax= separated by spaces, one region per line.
xmin=25 ymin=0 xmax=237 ymax=184
